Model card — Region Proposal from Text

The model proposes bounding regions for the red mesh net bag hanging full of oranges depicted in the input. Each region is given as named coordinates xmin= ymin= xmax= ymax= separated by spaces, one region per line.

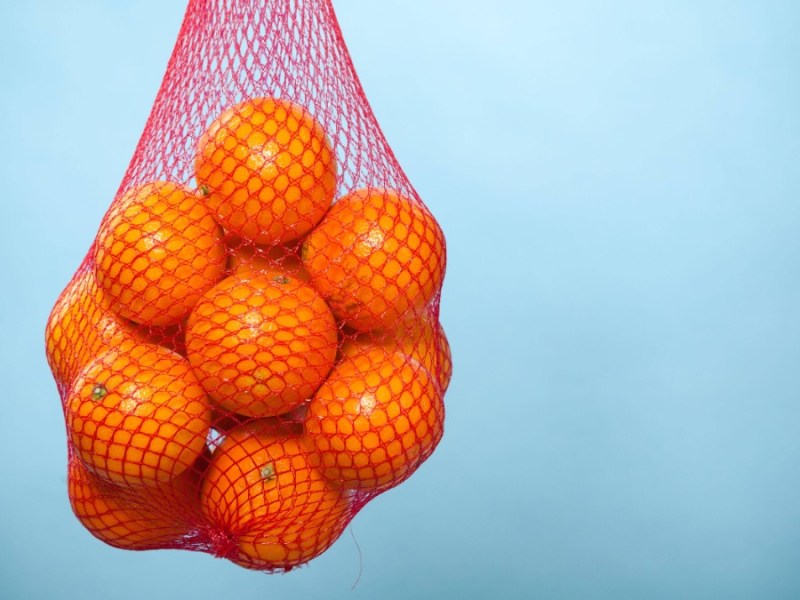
xmin=46 ymin=0 xmax=451 ymax=571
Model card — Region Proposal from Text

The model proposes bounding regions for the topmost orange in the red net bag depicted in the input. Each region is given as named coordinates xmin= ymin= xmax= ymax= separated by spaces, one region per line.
xmin=195 ymin=98 xmax=336 ymax=244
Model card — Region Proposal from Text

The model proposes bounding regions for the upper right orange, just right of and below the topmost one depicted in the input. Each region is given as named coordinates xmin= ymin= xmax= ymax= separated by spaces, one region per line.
xmin=301 ymin=188 xmax=445 ymax=331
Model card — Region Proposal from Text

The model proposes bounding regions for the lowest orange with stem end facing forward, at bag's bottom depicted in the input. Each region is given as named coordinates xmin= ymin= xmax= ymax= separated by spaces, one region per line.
xmin=200 ymin=421 xmax=351 ymax=569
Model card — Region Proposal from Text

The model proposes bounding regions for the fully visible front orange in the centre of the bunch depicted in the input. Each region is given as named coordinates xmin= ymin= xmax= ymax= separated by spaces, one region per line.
xmin=186 ymin=271 xmax=338 ymax=417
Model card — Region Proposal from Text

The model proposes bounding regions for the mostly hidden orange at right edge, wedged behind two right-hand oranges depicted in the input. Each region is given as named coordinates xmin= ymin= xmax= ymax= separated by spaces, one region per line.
xmin=339 ymin=316 xmax=453 ymax=395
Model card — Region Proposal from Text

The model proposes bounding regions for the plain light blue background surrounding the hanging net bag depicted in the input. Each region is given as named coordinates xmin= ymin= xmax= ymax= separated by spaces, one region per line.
xmin=0 ymin=0 xmax=800 ymax=599
